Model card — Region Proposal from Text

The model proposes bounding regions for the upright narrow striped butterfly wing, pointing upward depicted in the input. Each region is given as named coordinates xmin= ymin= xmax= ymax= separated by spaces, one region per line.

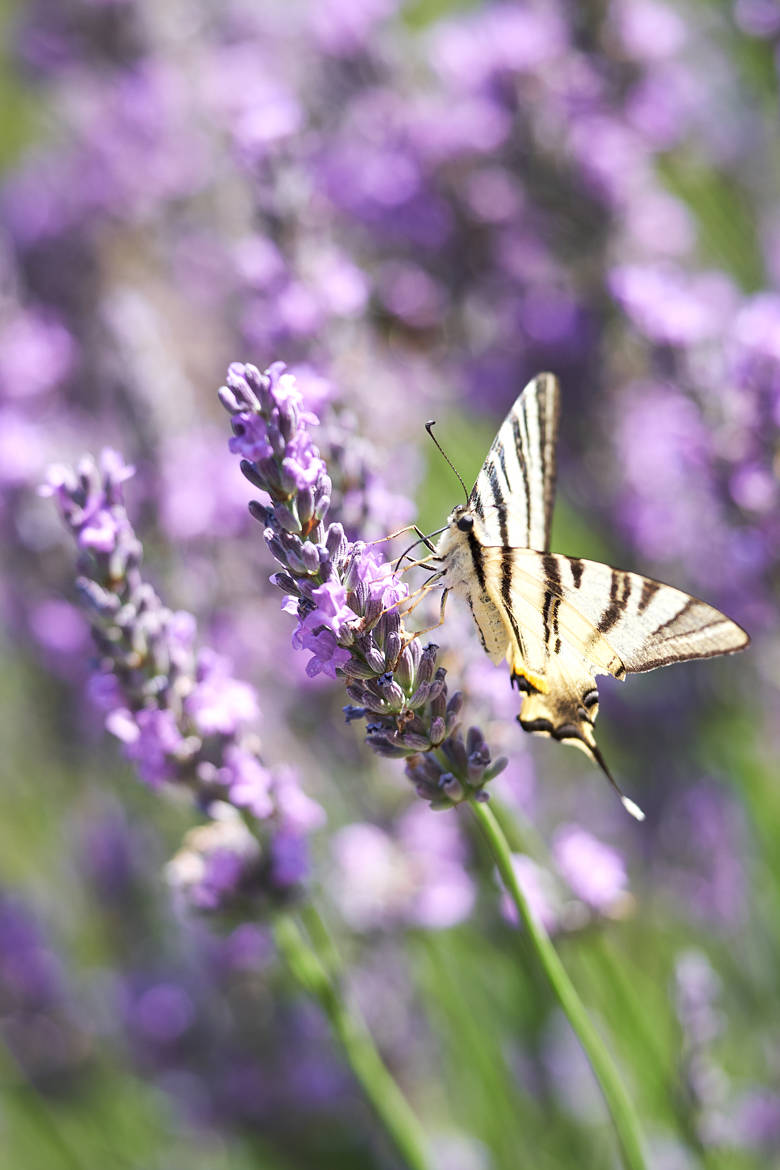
xmin=469 ymin=373 xmax=560 ymax=552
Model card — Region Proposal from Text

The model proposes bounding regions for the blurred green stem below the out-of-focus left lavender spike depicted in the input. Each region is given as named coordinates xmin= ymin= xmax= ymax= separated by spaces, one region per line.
xmin=274 ymin=914 xmax=428 ymax=1170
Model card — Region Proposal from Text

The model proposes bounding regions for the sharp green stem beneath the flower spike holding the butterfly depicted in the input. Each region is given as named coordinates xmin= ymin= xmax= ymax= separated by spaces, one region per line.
xmin=470 ymin=800 xmax=647 ymax=1170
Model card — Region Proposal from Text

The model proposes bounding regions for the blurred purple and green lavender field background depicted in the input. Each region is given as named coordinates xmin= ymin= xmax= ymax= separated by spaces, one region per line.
xmin=0 ymin=0 xmax=780 ymax=1170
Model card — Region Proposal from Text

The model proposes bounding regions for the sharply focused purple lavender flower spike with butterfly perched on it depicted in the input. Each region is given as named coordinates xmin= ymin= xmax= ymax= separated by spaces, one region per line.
xmin=220 ymin=362 xmax=506 ymax=808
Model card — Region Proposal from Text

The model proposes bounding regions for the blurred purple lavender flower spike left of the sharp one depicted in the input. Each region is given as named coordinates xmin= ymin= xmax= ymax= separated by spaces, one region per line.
xmin=41 ymin=450 xmax=324 ymax=908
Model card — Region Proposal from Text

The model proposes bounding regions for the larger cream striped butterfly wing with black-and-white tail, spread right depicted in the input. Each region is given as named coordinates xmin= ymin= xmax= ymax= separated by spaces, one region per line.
xmin=482 ymin=548 xmax=750 ymax=815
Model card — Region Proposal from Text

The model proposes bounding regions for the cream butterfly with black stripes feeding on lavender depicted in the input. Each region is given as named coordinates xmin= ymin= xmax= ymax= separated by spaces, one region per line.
xmin=430 ymin=373 xmax=750 ymax=820
